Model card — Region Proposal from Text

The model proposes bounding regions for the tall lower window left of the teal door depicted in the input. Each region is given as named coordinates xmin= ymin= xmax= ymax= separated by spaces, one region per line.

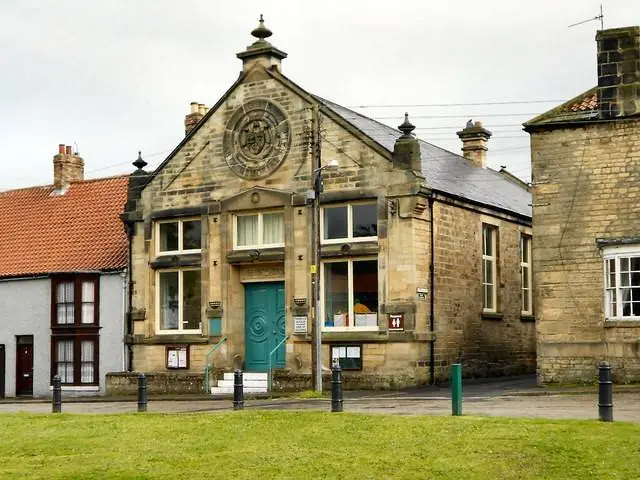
xmin=157 ymin=269 xmax=202 ymax=333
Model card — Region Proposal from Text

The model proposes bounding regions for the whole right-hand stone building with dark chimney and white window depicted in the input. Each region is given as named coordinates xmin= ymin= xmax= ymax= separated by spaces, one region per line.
xmin=525 ymin=27 xmax=640 ymax=382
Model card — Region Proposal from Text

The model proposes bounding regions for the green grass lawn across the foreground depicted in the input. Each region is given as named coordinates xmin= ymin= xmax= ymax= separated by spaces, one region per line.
xmin=0 ymin=410 xmax=640 ymax=480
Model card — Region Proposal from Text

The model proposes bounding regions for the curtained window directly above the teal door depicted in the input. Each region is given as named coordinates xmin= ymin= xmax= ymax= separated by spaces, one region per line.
xmin=233 ymin=211 xmax=284 ymax=250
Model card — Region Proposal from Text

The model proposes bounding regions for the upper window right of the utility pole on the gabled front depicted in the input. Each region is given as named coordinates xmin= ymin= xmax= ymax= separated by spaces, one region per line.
xmin=320 ymin=202 xmax=378 ymax=243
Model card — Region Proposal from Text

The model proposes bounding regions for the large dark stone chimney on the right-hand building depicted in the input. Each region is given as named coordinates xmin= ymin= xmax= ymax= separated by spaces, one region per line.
xmin=596 ymin=26 xmax=640 ymax=119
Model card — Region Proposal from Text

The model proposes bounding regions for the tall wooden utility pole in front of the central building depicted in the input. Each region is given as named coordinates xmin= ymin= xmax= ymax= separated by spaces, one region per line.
xmin=310 ymin=103 xmax=322 ymax=392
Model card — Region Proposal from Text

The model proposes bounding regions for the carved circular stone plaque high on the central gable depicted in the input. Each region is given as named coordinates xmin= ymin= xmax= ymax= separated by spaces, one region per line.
xmin=223 ymin=100 xmax=291 ymax=179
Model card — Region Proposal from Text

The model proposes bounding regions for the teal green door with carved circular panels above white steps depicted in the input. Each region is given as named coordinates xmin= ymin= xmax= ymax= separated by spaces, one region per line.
xmin=244 ymin=282 xmax=286 ymax=372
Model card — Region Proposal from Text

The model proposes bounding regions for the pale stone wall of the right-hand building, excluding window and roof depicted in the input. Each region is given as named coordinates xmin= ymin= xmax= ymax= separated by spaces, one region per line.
xmin=531 ymin=120 xmax=640 ymax=382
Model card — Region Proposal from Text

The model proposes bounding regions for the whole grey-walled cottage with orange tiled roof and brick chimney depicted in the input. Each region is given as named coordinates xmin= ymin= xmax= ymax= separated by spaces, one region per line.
xmin=0 ymin=145 xmax=128 ymax=397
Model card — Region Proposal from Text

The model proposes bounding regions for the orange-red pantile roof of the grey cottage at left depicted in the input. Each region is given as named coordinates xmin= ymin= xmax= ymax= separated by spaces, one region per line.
xmin=0 ymin=176 xmax=128 ymax=277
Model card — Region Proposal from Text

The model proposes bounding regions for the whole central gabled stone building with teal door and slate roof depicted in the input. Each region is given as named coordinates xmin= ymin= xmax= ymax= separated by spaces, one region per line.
xmin=119 ymin=22 xmax=535 ymax=390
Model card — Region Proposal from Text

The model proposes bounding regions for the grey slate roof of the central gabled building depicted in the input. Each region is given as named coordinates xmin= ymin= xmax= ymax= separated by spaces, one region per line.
xmin=315 ymin=96 xmax=531 ymax=218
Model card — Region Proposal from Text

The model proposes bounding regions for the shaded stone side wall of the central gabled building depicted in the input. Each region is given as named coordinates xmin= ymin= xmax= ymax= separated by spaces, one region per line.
xmin=434 ymin=201 xmax=535 ymax=379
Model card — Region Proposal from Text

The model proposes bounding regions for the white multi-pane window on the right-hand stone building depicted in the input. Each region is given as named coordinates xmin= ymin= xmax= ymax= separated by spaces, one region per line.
xmin=603 ymin=245 xmax=640 ymax=320
